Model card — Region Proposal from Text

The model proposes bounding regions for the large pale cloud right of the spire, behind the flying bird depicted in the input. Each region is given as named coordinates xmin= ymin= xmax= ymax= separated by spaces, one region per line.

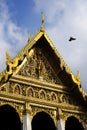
xmin=34 ymin=0 xmax=87 ymax=91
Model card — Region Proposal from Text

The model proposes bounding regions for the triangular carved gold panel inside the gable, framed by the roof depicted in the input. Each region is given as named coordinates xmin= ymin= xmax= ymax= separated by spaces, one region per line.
xmin=18 ymin=48 xmax=62 ymax=84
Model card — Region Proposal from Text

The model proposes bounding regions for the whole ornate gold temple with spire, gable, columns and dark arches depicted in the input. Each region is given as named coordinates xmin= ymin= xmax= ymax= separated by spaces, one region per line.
xmin=0 ymin=15 xmax=87 ymax=130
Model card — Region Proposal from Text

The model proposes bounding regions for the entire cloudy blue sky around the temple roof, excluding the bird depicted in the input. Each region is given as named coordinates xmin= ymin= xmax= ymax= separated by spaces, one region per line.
xmin=0 ymin=0 xmax=87 ymax=92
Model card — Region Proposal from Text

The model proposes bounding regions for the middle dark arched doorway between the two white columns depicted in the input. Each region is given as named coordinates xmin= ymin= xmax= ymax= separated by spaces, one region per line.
xmin=32 ymin=112 xmax=56 ymax=130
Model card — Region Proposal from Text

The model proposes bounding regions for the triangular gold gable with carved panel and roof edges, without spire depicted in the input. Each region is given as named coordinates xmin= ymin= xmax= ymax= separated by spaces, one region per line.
xmin=1 ymin=31 xmax=80 ymax=87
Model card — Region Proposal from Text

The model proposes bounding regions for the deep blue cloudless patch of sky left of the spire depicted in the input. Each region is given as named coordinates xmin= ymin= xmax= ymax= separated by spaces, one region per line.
xmin=4 ymin=0 xmax=41 ymax=33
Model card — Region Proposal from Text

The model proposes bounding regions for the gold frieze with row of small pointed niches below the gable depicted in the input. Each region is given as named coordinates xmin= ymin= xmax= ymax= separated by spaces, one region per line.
xmin=0 ymin=82 xmax=82 ymax=105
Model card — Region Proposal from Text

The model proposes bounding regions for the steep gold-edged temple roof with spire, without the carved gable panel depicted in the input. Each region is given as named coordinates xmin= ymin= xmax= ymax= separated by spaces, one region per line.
xmin=0 ymin=14 xmax=84 ymax=102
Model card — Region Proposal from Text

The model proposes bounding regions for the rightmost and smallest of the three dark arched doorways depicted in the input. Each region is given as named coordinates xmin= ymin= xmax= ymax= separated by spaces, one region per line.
xmin=65 ymin=116 xmax=84 ymax=130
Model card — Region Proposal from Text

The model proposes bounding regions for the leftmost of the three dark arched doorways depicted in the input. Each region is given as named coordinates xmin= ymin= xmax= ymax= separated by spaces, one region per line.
xmin=0 ymin=105 xmax=21 ymax=130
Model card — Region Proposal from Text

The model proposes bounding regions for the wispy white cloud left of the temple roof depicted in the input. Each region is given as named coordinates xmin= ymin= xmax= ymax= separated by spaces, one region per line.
xmin=0 ymin=0 xmax=26 ymax=71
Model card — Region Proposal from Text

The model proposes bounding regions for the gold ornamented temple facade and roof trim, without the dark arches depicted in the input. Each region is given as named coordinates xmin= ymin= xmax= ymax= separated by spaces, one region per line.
xmin=0 ymin=17 xmax=87 ymax=129
